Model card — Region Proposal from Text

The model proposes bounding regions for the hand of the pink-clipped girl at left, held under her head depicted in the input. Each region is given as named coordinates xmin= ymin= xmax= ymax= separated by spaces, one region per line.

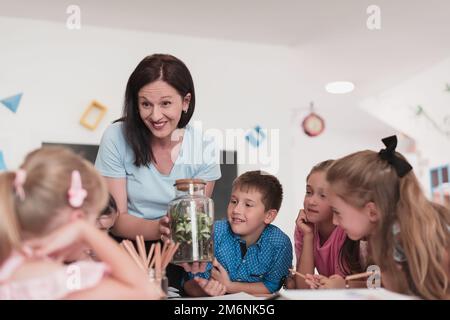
xmin=26 ymin=220 xmax=90 ymax=260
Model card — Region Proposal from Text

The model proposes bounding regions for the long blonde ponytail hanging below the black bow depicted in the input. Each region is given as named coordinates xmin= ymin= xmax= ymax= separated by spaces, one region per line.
xmin=396 ymin=173 xmax=450 ymax=299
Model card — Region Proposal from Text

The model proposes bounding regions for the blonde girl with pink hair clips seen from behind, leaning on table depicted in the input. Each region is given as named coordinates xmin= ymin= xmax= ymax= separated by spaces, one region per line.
xmin=0 ymin=147 xmax=163 ymax=300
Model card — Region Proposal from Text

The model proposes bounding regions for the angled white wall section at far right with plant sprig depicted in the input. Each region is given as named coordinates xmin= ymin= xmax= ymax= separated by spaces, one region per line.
xmin=361 ymin=58 xmax=450 ymax=195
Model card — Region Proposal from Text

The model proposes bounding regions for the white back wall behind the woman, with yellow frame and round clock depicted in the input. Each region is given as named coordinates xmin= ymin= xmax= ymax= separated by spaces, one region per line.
xmin=0 ymin=18 xmax=393 ymax=249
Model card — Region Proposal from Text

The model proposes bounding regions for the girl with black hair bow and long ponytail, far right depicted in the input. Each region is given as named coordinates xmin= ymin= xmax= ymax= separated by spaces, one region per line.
xmin=327 ymin=136 xmax=450 ymax=299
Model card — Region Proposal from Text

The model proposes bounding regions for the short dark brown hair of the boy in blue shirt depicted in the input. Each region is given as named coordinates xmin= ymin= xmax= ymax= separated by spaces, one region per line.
xmin=232 ymin=170 xmax=283 ymax=211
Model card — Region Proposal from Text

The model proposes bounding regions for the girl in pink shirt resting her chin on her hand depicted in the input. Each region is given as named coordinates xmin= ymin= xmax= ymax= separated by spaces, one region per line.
xmin=294 ymin=160 xmax=361 ymax=288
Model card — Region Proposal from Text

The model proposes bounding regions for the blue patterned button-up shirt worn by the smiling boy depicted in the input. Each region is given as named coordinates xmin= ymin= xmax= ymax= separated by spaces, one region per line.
xmin=189 ymin=220 xmax=292 ymax=292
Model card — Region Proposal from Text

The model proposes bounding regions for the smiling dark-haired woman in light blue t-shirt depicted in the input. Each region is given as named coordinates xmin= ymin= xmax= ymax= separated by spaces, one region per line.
xmin=95 ymin=54 xmax=221 ymax=250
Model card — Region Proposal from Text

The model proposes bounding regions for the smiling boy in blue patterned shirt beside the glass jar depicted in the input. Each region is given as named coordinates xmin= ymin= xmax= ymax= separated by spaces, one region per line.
xmin=184 ymin=171 xmax=292 ymax=296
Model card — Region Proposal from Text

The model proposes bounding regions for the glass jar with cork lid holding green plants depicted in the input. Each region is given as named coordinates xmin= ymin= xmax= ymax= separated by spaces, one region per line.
xmin=169 ymin=179 xmax=214 ymax=264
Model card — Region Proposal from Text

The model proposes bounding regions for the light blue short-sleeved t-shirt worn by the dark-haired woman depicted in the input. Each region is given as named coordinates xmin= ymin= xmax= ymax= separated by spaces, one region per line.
xmin=95 ymin=122 xmax=221 ymax=219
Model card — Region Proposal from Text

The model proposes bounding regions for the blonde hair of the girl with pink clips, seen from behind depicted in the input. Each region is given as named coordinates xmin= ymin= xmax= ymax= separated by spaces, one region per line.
xmin=0 ymin=147 xmax=108 ymax=264
